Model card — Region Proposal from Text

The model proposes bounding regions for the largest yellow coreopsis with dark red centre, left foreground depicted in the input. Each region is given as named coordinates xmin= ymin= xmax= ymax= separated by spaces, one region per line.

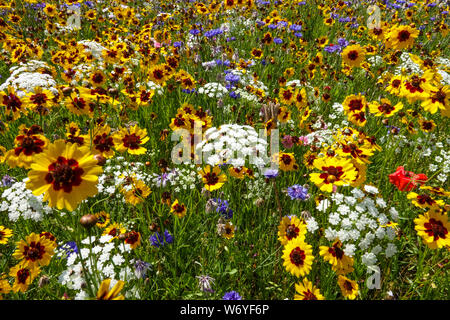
xmin=26 ymin=140 xmax=103 ymax=211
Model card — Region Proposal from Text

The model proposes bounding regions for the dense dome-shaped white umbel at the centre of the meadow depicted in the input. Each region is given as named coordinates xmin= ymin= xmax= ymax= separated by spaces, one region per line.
xmin=196 ymin=124 xmax=270 ymax=168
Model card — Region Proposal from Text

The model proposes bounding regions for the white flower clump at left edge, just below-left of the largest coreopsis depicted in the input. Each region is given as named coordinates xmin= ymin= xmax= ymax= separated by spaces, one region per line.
xmin=0 ymin=178 xmax=53 ymax=222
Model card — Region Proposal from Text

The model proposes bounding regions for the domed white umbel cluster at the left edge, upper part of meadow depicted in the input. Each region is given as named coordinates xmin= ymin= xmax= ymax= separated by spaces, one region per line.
xmin=0 ymin=60 xmax=58 ymax=97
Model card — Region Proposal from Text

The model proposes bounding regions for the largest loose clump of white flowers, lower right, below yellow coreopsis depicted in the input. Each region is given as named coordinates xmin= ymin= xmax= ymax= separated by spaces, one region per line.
xmin=316 ymin=185 xmax=398 ymax=266
